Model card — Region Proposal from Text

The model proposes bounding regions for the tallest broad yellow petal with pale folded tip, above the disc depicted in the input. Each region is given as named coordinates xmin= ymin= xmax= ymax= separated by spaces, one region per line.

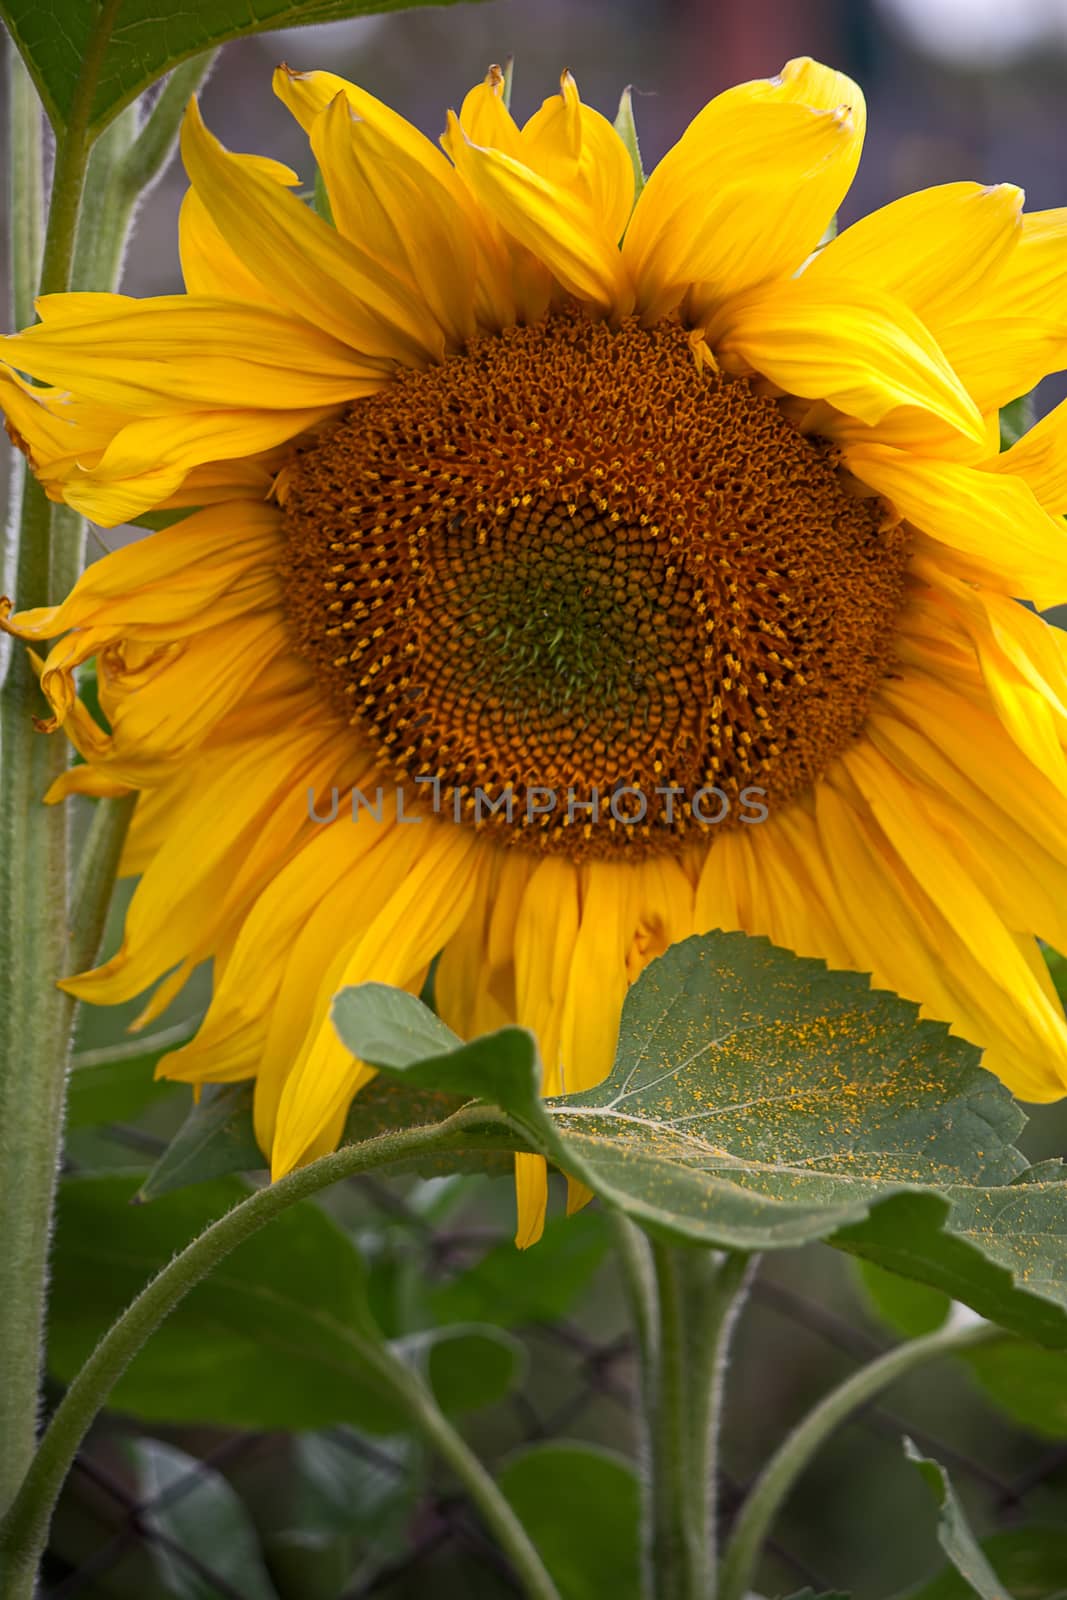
xmin=622 ymin=59 xmax=865 ymax=320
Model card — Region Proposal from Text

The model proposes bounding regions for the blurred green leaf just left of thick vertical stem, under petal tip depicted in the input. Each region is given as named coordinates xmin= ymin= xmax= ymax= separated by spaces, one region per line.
xmin=429 ymin=1211 xmax=609 ymax=1326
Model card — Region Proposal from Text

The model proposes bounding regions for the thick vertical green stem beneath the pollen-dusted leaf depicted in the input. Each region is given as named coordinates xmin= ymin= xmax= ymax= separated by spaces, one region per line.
xmin=630 ymin=1219 xmax=753 ymax=1600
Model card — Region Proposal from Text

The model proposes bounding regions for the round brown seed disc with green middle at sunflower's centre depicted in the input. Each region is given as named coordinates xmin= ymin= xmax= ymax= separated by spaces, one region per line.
xmin=285 ymin=299 xmax=909 ymax=858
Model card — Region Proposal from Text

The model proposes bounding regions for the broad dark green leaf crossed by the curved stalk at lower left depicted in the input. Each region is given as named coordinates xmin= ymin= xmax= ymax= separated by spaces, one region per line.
xmin=48 ymin=1176 xmax=523 ymax=1434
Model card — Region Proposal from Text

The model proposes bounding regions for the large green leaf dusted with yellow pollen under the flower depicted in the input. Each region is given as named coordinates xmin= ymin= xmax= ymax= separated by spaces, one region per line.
xmin=334 ymin=933 xmax=1067 ymax=1344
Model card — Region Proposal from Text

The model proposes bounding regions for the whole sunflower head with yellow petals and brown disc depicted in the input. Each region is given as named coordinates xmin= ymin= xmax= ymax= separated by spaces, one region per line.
xmin=0 ymin=59 xmax=1067 ymax=1243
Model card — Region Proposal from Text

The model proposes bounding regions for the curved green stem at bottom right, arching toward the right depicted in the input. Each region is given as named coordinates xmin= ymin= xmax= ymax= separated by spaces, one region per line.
xmin=718 ymin=1323 xmax=1009 ymax=1600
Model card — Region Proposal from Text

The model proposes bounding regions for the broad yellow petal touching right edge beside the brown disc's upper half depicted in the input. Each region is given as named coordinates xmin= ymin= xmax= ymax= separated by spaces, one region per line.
xmin=846 ymin=445 xmax=1067 ymax=606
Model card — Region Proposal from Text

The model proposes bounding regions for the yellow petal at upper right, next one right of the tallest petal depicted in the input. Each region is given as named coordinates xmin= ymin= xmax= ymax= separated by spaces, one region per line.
xmin=805 ymin=182 xmax=1022 ymax=326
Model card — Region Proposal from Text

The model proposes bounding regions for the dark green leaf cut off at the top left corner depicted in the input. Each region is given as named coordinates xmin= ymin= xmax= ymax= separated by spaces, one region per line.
xmin=0 ymin=0 xmax=492 ymax=136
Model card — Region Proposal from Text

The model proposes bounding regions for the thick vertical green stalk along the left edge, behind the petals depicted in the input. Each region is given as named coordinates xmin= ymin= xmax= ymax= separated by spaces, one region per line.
xmin=0 ymin=37 xmax=70 ymax=1510
